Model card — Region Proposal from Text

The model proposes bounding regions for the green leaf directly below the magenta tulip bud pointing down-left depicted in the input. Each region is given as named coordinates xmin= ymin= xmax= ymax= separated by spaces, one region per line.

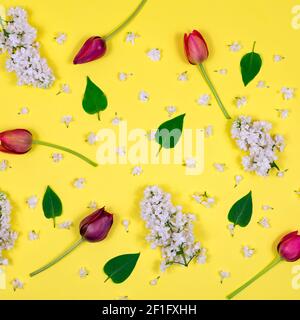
xmin=82 ymin=77 xmax=107 ymax=120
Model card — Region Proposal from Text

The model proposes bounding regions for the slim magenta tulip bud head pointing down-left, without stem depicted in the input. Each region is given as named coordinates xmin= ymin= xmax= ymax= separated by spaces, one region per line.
xmin=73 ymin=36 xmax=106 ymax=64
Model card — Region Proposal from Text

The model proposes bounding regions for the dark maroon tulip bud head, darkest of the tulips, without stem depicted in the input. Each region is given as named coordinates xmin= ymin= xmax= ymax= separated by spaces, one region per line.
xmin=79 ymin=207 xmax=113 ymax=242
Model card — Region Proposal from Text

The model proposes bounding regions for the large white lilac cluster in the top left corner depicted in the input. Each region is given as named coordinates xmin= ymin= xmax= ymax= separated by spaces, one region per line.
xmin=0 ymin=7 xmax=55 ymax=88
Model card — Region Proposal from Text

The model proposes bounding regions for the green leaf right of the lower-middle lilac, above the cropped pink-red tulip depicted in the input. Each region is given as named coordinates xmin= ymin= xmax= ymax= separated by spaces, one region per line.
xmin=228 ymin=191 xmax=253 ymax=227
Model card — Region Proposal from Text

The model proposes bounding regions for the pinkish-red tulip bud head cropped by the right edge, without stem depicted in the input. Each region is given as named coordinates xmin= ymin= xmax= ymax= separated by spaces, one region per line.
xmin=277 ymin=231 xmax=300 ymax=262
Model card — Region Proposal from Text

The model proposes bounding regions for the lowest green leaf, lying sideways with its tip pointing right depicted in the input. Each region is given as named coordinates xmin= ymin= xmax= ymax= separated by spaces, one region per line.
xmin=103 ymin=253 xmax=140 ymax=283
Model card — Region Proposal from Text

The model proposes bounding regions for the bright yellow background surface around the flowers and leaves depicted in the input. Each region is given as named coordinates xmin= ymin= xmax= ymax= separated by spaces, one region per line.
xmin=0 ymin=0 xmax=300 ymax=299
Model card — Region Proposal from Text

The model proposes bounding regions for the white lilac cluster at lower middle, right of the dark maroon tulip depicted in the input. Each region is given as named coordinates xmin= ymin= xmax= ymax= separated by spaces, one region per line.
xmin=141 ymin=186 xmax=202 ymax=271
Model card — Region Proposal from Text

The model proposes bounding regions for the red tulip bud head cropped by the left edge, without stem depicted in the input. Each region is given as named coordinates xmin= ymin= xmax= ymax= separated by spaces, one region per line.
xmin=0 ymin=129 xmax=32 ymax=154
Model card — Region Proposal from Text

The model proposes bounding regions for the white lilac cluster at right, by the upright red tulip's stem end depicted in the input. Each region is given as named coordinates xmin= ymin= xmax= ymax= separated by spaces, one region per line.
xmin=231 ymin=116 xmax=285 ymax=176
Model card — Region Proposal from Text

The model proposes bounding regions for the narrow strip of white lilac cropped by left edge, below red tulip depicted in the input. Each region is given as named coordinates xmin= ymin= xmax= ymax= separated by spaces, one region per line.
xmin=0 ymin=192 xmax=18 ymax=265
